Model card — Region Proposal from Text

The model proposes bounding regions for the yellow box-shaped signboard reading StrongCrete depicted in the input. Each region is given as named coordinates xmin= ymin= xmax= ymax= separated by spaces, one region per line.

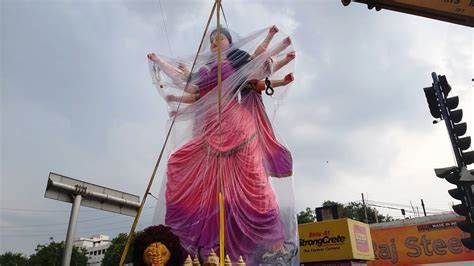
xmin=298 ymin=219 xmax=374 ymax=263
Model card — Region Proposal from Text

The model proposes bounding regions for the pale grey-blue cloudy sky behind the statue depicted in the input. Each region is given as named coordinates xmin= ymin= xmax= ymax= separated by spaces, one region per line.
xmin=0 ymin=0 xmax=474 ymax=254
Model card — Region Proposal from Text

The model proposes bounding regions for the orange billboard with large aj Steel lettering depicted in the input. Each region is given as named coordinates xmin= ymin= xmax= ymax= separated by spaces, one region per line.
xmin=368 ymin=217 xmax=474 ymax=265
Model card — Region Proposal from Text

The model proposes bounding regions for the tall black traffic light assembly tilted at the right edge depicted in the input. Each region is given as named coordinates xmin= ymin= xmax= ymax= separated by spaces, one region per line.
xmin=423 ymin=73 xmax=474 ymax=250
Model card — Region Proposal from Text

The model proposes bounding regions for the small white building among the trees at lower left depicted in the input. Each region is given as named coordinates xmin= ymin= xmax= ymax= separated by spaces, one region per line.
xmin=74 ymin=235 xmax=112 ymax=265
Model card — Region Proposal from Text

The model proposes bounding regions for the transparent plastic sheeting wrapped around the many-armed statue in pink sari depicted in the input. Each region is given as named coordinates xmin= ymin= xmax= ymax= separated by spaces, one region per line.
xmin=148 ymin=26 xmax=298 ymax=265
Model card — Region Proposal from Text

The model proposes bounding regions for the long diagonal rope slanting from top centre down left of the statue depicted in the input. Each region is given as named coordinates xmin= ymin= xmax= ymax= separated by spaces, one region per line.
xmin=119 ymin=3 xmax=216 ymax=266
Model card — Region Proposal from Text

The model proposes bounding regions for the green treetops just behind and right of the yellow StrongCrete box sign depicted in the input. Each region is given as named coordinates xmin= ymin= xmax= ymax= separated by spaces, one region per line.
xmin=323 ymin=200 xmax=393 ymax=224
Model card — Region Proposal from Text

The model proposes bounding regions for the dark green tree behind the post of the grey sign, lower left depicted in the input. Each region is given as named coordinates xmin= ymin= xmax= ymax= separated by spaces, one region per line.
xmin=28 ymin=241 xmax=87 ymax=266
